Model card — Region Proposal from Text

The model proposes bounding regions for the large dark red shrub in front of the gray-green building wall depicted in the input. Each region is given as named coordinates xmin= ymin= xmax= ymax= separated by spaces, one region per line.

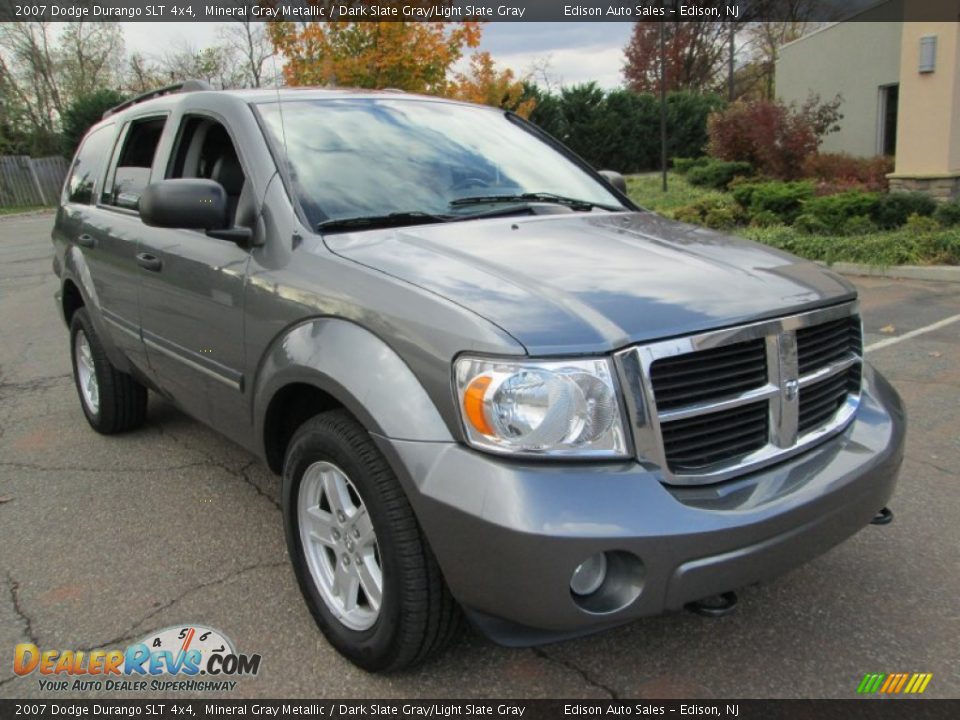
xmin=707 ymin=94 xmax=842 ymax=180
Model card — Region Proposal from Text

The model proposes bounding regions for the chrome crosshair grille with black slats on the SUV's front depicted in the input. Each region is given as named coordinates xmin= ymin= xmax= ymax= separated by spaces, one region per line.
xmin=618 ymin=303 xmax=863 ymax=484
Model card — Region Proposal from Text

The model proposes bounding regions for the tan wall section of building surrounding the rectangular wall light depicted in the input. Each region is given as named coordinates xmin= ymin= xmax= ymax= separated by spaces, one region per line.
xmin=894 ymin=22 xmax=960 ymax=176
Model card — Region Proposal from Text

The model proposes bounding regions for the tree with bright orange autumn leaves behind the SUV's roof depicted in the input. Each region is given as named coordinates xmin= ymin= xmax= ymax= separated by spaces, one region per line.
xmin=269 ymin=20 xmax=481 ymax=94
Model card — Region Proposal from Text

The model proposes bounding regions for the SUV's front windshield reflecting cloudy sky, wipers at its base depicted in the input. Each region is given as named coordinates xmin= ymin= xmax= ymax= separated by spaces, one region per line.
xmin=258 ymin=98 xmax=622 ymax=227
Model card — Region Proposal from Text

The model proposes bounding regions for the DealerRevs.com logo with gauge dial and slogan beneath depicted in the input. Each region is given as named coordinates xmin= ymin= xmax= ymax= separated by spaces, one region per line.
xmin=13 ymin=625 xmax=261 ymax=692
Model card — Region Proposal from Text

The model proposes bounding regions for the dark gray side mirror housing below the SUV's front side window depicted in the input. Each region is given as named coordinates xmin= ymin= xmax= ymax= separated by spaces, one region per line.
xmin=139 ymin=178 xmax=227 ymax=230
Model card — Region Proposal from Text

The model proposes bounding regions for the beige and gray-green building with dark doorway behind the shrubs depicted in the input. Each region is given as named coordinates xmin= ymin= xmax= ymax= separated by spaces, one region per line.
xmin=776 ymin=0 xmax=960 ymax=199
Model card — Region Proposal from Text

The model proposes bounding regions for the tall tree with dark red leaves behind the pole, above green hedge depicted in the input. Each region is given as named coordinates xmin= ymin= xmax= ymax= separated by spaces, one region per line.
xmin=623 ymin=13 xmax=729 ymax=93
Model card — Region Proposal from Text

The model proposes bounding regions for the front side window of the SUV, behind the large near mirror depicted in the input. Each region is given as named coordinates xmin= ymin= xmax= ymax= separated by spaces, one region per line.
xmin=167 ymin=117 xmax=253 ymax=227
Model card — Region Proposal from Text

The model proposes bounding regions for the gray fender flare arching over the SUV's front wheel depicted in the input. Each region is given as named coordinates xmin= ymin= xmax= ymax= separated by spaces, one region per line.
xmin=253 ymin=317 xmax=453 ymax=456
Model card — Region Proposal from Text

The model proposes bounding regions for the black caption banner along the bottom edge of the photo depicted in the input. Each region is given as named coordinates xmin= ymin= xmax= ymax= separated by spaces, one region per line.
xmin=0 ymin=698 xmax=960 ymax=720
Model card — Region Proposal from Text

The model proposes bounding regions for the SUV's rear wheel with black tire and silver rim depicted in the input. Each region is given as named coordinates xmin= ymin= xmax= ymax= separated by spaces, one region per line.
xmin=70 ymin=308 xmax=147 ymax=435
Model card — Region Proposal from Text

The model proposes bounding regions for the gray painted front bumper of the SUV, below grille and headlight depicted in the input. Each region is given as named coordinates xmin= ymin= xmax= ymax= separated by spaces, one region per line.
xmin=378 ymin=365 xmax=906 ymax=645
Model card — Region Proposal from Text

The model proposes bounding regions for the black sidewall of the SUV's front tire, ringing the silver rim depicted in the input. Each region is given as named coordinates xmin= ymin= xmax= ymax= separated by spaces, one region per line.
xmin=283 ymin=420 xmax=403 ymax=670
